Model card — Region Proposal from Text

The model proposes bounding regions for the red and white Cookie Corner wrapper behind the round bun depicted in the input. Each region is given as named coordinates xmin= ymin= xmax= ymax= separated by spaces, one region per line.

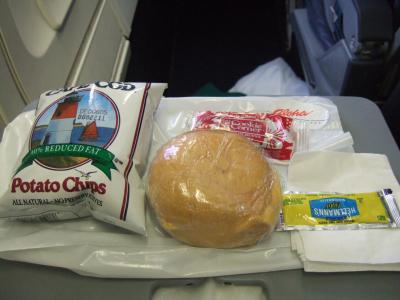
xmin=192 ymin=111 xmax=294 ymax=161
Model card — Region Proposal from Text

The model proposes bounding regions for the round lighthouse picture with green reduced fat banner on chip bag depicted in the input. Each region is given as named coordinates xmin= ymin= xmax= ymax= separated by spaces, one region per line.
xmin=27 ymin=89 xmax=120 ymax=171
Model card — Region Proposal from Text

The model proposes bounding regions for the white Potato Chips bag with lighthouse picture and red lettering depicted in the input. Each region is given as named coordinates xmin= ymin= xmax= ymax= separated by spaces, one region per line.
xmin=0 ymin=81 xmax=166 ymax=234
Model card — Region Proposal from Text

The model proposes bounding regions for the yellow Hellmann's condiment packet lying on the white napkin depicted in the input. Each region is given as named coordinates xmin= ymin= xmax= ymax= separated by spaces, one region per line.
xmin=280 ymin=189 xmax=400 ymax=230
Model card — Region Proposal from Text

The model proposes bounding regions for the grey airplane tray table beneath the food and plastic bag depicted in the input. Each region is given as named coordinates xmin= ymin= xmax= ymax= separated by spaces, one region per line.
xmin=0 ymin=97 xmax=400 ymax=300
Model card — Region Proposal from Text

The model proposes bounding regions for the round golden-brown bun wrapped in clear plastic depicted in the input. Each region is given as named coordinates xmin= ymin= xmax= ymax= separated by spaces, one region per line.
xmin=148 ymin=130 xmax=282 ymax=248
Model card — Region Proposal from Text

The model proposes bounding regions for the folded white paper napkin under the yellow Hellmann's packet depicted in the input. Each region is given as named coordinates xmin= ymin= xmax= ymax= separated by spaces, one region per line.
xmin=287 ymin=152 xmax=400 ymax=272
